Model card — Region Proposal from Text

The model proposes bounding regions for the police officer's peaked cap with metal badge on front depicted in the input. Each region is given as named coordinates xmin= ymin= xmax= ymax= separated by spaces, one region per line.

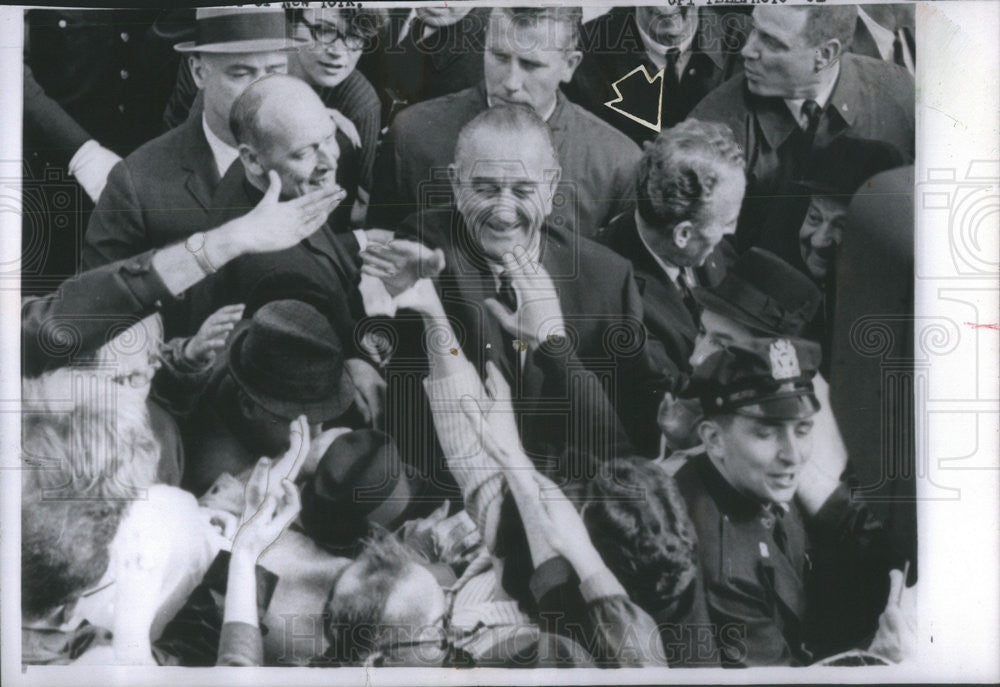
xmin=685 ymin=338 xmax=821 ymax=420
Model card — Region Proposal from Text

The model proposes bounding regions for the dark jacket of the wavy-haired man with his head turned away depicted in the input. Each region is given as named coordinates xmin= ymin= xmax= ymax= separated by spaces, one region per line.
xmin=598 ymin=212 xmax=736 ymax=391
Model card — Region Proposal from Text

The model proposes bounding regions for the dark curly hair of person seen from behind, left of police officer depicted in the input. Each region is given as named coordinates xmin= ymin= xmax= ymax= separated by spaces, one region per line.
xmin=571 ymin=457 xmax=697 ymax=613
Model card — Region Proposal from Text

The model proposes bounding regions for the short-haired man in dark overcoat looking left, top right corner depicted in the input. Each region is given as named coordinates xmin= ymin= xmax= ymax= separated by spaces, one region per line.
xmin=691 ymin=5 xmax=914 ymax=250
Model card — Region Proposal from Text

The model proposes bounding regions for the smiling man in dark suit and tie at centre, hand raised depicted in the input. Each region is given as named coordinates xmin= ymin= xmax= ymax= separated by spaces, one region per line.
xmin=376 ymin=105 xmax=663 ymax=482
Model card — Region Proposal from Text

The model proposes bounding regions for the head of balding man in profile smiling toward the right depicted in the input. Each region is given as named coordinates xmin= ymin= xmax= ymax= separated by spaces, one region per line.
xmin=256 ymin=94 xmax=340 ymax=198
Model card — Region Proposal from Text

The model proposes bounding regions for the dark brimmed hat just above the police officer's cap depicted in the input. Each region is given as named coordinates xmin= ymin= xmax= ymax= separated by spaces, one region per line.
xmin=693 ymin=248 xmax=823 ymax=336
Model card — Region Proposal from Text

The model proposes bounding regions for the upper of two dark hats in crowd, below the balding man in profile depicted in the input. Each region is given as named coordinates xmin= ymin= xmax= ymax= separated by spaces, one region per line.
xmin=227 ymin=300 xmax=354 ymax=424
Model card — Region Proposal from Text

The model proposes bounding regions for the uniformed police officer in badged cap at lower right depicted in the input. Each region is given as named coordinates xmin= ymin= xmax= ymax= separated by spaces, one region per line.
xmin=676 ymin=338 xmax=902 ymax=666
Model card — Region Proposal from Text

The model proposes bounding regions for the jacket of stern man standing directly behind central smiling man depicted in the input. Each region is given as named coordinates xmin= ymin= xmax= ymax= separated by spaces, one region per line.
xmin=368 ymin=84 xmax=641 ymax=237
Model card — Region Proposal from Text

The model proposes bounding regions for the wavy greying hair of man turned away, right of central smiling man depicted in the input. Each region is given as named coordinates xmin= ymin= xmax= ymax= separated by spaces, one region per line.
xmin=636 ymin=119 xmax=744 ymax=227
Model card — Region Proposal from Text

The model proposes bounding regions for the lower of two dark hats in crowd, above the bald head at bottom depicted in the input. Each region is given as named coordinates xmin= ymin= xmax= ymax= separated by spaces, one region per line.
xmin=301 ymin=429 xmax=423 ymax=551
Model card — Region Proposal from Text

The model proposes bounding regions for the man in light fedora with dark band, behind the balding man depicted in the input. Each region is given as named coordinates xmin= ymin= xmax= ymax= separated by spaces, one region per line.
xmin=83 ymin=8 xmax=295 ymax=269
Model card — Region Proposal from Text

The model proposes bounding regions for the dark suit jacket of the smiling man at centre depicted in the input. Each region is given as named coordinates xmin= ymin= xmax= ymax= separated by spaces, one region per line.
xmin=400 ymin=210 xmax=665 ymax=459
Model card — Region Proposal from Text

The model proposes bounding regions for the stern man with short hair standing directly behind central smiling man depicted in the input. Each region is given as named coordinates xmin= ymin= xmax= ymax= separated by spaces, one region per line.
xmin=368 ymin=7 xmax=639 ymax=237
